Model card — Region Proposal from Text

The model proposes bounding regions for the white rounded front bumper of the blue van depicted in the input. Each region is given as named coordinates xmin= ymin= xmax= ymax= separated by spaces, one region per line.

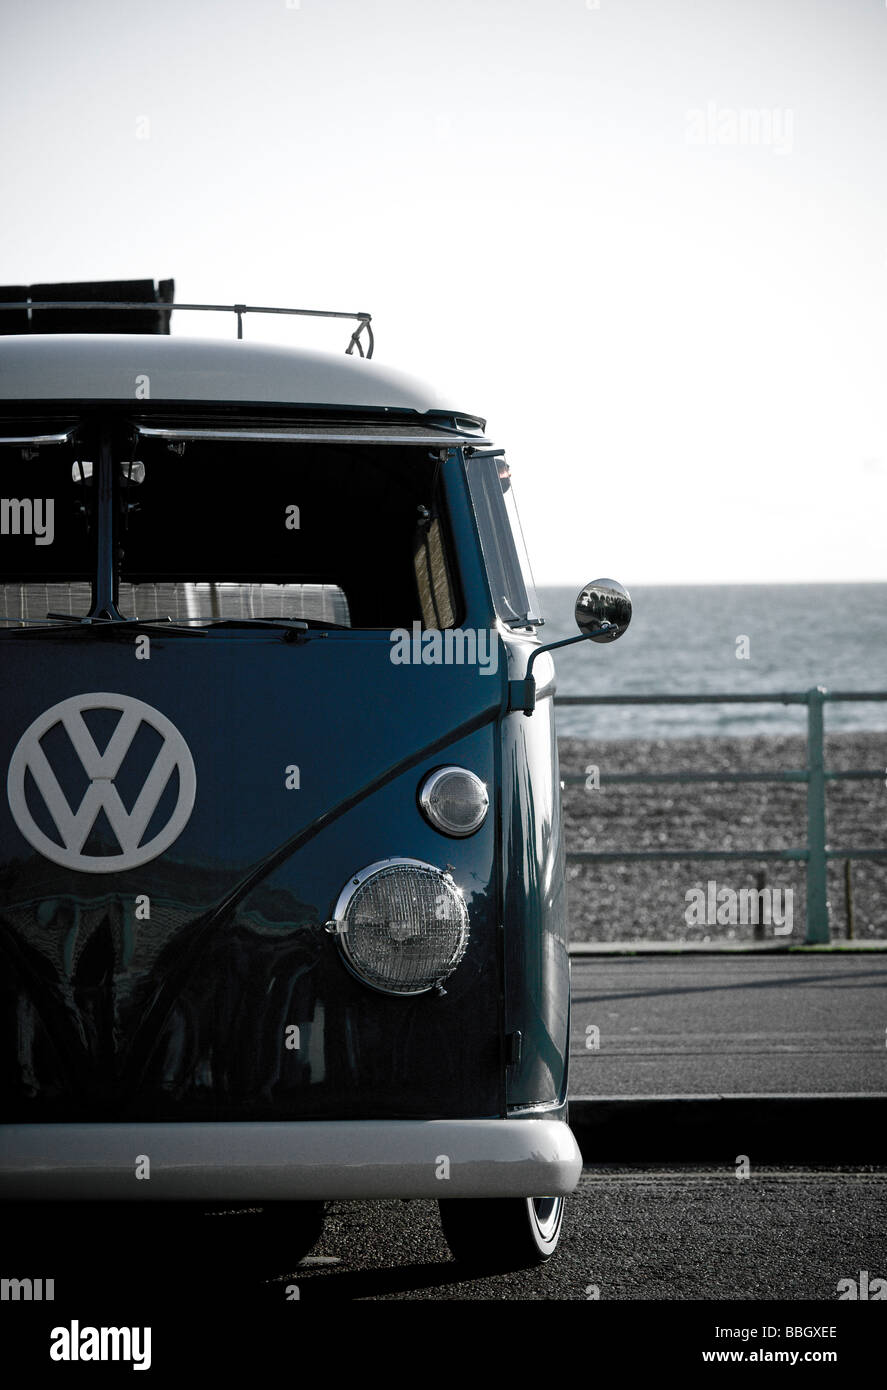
xmin=0 ymin=1119 xmax=583 ymax=1202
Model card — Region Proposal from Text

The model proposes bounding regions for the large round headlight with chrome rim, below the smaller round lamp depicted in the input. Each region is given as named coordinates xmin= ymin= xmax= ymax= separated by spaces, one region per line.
xmin=325 ymin=859 xmax=469 ymax=994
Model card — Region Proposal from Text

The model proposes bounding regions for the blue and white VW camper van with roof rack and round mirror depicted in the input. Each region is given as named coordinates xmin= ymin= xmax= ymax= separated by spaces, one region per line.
xmin=0 ymin=281 xmax=631 ymax=1265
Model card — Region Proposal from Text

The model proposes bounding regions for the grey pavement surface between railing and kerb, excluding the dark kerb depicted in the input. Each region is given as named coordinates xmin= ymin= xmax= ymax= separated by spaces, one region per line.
xmin=570 ymin=952 xmax=887 ymax=1095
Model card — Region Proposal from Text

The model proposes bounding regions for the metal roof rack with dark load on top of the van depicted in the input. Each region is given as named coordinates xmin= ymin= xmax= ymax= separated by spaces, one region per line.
xmin=0 ymin=281 xmax=375 ymax=359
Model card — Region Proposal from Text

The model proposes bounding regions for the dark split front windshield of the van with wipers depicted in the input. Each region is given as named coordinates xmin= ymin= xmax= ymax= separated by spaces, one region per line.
xmin=0 ymin=428 xmax=462 ymax=631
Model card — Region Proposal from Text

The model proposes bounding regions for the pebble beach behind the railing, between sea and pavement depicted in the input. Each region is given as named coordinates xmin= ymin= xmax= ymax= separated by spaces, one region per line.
xmin=559 ymin=733 xmax=887 ymax=944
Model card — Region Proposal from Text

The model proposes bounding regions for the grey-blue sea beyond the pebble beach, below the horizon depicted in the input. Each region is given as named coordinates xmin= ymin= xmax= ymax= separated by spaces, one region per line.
xmin=538 ymin=584 xmax=887 ymax=739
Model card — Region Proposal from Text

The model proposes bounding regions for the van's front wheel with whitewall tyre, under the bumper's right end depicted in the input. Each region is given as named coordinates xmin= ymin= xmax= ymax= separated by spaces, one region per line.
xmin=438 ymin=1197 xmax=564 ymax=1269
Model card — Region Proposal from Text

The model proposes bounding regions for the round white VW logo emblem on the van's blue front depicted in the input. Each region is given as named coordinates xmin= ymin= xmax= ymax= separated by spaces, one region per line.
xmin=7 ymin=691 xmax=197 ymax=873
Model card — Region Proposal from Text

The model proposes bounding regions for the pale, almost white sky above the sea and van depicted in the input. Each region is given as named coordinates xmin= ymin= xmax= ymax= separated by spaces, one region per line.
xmin=0 ymin=0 xmax=887 ymax=587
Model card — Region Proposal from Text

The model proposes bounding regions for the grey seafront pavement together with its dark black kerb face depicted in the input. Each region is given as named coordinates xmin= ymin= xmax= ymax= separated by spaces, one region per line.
xmin=570 ymin=949 xmax=887 ymax=1163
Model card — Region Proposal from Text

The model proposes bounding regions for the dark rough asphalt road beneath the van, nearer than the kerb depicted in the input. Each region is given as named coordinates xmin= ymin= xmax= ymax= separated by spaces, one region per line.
xmin=279 ymin=1165 xmax=887 ymax=1302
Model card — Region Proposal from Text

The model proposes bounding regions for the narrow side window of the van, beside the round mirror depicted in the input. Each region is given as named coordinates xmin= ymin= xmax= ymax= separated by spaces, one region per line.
xmin=469 ymin=455 xmax=544 ymax=624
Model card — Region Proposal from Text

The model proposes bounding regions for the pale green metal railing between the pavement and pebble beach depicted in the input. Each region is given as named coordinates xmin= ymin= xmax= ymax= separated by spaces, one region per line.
xmin=555 ymin=685 xmax=887 ymax=945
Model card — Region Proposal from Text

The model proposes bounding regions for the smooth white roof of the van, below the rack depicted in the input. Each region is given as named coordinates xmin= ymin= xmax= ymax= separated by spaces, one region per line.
xmin=0 ymin=334 xmax=472 ymax=414
